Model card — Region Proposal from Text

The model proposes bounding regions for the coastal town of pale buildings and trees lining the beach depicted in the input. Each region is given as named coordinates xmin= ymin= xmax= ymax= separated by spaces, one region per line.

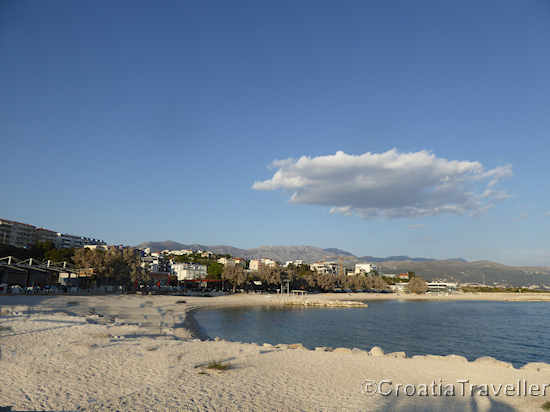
xmin=0 ymin=219 xmax=544 ymax=294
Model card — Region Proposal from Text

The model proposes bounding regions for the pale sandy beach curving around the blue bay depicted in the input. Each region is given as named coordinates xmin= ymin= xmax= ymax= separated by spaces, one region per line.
xmin=0 ymin=295 xmax=550 ymax=411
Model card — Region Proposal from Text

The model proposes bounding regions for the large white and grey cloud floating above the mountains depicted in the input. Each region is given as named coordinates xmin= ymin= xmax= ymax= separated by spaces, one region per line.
xmin=252 ymin=149 xmax=512 ymax=218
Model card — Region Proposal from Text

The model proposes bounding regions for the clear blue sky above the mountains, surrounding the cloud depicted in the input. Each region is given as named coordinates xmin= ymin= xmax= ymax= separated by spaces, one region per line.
xmin=0 ymin=0 xmax=550 ymax=265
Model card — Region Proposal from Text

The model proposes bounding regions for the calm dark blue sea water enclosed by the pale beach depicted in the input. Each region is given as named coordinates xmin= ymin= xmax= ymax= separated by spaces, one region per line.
xmin=195 ymin=300 xmax=550 ymax=367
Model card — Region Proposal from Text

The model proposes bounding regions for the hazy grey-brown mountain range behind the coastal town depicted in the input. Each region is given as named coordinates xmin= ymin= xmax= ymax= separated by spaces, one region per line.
xmin=137 ymin=240 xmax=550 ymax=287
